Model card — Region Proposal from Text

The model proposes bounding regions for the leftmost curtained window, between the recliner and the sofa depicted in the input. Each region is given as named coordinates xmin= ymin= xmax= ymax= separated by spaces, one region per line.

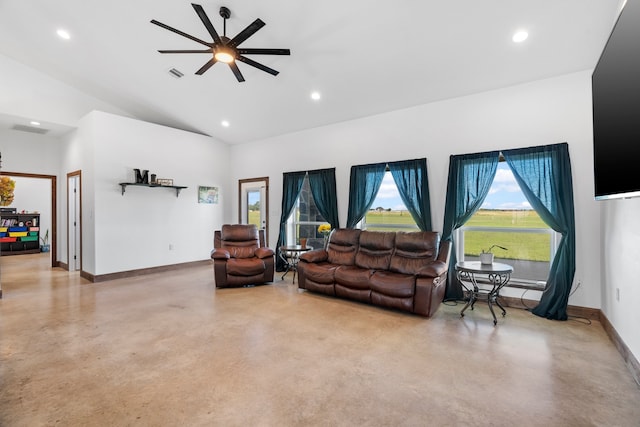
xmin=286 ymin=176 xmax=328 ymax=248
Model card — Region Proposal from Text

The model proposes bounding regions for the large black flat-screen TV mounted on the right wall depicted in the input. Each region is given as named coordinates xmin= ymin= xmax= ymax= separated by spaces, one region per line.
xmin=591 ymin=0 xmax=640 ymax=200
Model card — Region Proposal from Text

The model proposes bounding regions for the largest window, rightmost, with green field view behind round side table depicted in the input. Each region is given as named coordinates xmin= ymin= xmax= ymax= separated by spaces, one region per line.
xmin=456 ymin=162 xmax=560 ymax=288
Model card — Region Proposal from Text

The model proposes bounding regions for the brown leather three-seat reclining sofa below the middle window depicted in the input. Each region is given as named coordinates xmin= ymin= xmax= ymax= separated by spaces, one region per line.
xmin=298 ymin=229 xmax=450 ymax=317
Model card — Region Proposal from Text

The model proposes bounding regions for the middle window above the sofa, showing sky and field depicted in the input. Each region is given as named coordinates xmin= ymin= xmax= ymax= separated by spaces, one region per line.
xmin=359 ymin=171 xmax=418 ymax=231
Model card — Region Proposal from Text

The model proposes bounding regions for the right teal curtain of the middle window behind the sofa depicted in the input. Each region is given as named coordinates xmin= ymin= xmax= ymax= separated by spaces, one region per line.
xmin=389 ymin=158 xmax=431 ymax=231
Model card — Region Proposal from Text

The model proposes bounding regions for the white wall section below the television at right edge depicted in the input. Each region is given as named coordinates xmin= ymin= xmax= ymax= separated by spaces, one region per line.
xmin=604 ymin=198 xmax=640 ymax=360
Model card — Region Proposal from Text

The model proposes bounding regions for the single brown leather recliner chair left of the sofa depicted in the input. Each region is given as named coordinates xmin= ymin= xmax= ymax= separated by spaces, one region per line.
xmin=211 ymin=224 xmax=275 ymax=288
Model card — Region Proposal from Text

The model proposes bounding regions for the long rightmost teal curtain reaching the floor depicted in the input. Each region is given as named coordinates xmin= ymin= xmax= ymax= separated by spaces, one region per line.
xmin=502 ymin=143 xmax=576 ymax=320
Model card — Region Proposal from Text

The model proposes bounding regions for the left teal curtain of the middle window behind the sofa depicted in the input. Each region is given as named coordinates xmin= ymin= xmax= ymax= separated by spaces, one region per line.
xmin=347 ymin=163 xmax=387 ymax=228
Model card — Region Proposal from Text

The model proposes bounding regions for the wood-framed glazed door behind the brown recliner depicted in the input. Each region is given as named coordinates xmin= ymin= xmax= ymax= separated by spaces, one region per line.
xmin=238 ymin=177 xmax=269 ymax=245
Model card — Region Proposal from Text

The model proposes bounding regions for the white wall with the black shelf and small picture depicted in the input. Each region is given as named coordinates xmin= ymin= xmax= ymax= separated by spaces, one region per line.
xmin=75 ymin=111 xmax=231 ymax=275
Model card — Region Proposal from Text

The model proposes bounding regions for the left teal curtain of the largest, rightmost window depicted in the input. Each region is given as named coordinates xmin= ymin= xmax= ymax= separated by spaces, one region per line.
xmin=442 ymin=151 xmax=500 ymax=300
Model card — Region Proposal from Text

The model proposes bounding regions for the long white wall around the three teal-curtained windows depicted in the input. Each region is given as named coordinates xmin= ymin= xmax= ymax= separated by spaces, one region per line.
xmin=231 ymin=71 xmax=601 ymax=308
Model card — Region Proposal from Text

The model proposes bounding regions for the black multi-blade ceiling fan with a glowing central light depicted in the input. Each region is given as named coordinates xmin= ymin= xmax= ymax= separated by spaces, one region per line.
xmin=151 ymin=3 xmax=291 ymax=82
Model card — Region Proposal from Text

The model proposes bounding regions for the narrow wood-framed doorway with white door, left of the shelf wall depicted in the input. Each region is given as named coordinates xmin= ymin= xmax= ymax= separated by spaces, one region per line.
xmin=67 ymin=171 xmax=82 ymax=271
